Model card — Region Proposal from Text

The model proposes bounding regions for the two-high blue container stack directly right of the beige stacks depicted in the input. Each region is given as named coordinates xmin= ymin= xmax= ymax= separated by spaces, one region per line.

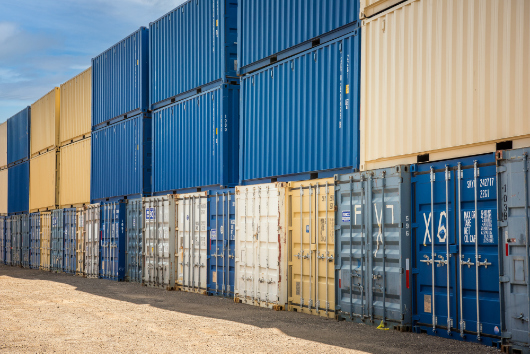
xmin=90 ymin=27 xmax=152 ymax=202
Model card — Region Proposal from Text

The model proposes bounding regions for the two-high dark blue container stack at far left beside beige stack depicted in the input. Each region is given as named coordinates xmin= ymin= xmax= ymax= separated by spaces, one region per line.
xmin=7 ymin=107 xmax=31 ymax=214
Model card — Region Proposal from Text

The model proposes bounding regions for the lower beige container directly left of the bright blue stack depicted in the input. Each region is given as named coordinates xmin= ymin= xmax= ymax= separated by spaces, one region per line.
xmin=59 ymin=138 xmax=91 ymax=208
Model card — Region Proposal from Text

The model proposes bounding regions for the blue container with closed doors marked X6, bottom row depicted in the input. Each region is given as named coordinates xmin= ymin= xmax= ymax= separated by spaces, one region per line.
xmin=411 ymin=154 xmax=500 ymax=345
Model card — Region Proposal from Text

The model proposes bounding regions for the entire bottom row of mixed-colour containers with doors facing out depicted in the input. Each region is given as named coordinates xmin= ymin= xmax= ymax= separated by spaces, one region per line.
xmin=0 ymin=146 xmax=530 ymax=349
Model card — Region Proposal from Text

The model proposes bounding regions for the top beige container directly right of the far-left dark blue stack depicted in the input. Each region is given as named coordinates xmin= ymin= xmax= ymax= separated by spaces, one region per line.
xmin=30 ymin=87 xmax=61 ymax=156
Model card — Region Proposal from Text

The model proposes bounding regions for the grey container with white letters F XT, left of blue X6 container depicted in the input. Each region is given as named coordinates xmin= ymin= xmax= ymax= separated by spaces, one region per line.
xmin=335 ymin=165 xmax=412 ymax=331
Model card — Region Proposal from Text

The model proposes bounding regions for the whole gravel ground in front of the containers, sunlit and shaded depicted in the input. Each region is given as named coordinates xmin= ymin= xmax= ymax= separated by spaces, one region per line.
xmin=0 ymin=265 xmax=497 ymax=353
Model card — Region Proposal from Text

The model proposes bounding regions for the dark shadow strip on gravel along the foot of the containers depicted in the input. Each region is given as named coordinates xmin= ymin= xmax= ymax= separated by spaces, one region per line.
xmin=0 ymin=265 xmax=496 ymax=353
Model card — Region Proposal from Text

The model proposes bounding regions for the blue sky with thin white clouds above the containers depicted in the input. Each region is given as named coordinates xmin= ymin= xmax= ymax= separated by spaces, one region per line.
xmin=0 ymin=0 xmax=185 ymax=123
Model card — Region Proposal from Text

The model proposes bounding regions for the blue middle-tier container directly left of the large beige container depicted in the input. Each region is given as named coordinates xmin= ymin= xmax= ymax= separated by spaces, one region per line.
xmin=240 ymin=30 xmax=361 ymax=181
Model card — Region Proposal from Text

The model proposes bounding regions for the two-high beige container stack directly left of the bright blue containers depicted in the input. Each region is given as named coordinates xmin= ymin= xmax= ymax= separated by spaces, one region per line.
xmin=58 ymin=68 xmax=92 ymax=208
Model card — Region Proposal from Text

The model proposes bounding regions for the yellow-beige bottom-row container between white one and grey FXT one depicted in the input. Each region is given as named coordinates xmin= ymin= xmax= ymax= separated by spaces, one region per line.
xmin=285 ymin=178 xmax=335 ymax=318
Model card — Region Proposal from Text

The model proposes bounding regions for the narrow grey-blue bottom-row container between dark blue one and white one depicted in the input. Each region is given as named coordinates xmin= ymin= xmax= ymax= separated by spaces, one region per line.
xmin=127 ymin=199 xmax=143 ymax=283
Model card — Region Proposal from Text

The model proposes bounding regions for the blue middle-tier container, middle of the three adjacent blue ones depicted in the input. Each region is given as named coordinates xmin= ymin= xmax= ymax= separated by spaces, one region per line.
xmin=153 ymin=85 xmax=239 ymax=193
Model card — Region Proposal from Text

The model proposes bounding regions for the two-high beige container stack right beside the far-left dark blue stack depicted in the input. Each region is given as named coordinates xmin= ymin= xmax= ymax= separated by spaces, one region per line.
xmin=29 ymin=87 xmax=61 ymax=212
